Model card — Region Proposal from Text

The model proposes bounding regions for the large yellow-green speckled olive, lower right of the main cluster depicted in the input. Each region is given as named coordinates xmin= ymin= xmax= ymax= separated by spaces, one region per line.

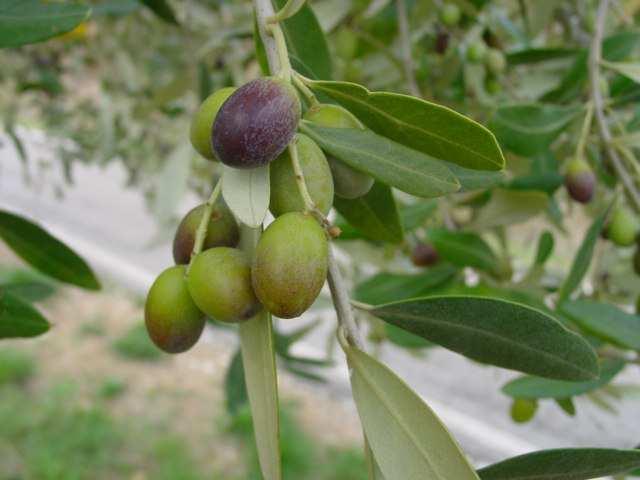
xmin=252 ymin=212 xmax=329 ymax=318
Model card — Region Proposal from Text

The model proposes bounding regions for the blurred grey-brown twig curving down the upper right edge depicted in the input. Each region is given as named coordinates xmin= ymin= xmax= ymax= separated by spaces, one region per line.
xmin=589 ymin=0 xmax=640 ymax=212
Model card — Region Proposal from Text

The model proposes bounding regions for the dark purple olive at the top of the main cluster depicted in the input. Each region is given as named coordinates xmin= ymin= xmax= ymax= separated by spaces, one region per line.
xmin=212 ymin=77 xmax=301 ymax=168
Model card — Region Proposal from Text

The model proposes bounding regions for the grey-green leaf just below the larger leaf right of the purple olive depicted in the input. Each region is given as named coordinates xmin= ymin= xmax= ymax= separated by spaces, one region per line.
xmin=300 ymin=121 xmax=460 ymax=201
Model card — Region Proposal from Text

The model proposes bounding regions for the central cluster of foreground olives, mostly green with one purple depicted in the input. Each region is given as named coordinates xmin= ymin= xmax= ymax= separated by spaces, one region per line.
xmin=145 ymin=77 xmax=373 ymax=353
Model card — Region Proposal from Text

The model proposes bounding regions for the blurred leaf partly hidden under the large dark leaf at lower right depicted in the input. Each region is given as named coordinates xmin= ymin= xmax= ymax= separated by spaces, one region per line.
xmin=502 ymin=360 xmax=625 ymax=399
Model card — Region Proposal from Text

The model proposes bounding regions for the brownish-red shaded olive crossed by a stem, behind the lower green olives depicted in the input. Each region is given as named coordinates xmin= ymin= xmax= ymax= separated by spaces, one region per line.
xmin=173 ymin=198 xmax=240 ymax=264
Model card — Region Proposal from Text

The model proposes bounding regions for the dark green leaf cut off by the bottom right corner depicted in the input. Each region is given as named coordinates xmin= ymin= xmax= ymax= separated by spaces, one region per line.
xmin=478 ymin=448 xmax=640 ymax=480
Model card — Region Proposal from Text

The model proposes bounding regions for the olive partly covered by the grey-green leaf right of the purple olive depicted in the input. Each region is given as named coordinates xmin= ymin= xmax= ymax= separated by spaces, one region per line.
xmin=304 ymin=104 xmax=373 ymax=199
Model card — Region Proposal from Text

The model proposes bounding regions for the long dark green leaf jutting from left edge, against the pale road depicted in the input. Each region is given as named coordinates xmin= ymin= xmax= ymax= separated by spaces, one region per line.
xmin=0 ymin=210 xmax=100 ymax=290
